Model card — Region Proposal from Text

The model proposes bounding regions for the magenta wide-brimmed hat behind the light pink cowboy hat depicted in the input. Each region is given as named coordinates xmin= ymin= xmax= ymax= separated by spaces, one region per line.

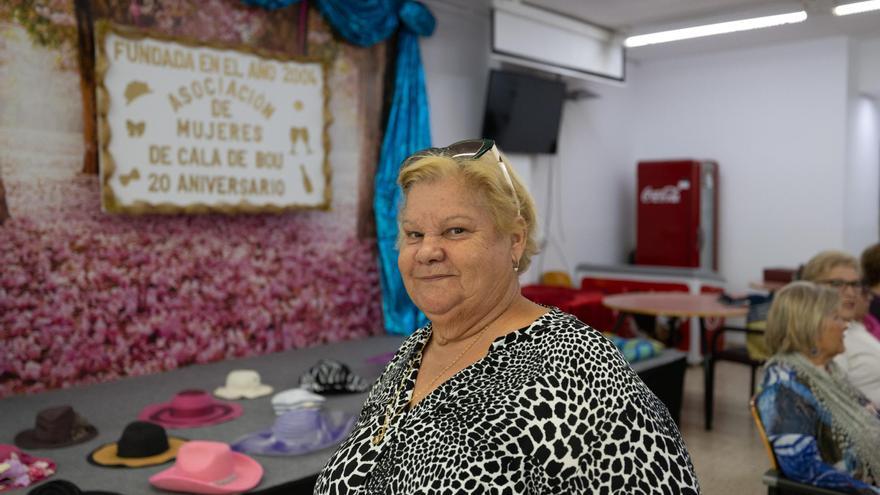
xmin=138 ymin=390 xmax=242 ymax=428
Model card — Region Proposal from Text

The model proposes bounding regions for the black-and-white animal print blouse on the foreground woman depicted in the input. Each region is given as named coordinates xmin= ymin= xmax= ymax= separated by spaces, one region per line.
xmin=315 ymin=309 xmax=700 ymax=495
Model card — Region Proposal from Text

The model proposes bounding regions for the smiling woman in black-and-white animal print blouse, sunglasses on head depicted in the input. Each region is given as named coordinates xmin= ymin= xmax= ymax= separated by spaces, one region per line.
xmin=315 ymin=140 xmax=699 ymax=494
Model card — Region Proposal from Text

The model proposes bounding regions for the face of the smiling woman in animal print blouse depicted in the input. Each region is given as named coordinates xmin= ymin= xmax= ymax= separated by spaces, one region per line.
xmin=397 ymin=177 xmax=523 ymax=320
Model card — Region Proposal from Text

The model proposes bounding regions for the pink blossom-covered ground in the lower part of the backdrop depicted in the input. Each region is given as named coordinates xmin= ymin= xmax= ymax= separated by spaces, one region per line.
xmin=0 ymin=177 xmax=381 ymax=397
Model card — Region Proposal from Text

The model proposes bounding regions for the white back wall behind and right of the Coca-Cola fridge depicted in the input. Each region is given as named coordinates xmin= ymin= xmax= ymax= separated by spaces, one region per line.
xmin=633 ymin=38 xmax=849 ymax=290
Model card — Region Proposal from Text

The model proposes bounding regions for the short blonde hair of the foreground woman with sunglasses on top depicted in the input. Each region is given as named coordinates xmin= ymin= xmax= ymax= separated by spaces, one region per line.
xmin=397 ymin=150 xmax=538 ymax=273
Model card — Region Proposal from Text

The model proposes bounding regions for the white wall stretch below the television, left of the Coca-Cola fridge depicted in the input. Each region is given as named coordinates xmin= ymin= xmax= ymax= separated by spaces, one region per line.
xmin=533 ymin=80 xmax=636 ymax=272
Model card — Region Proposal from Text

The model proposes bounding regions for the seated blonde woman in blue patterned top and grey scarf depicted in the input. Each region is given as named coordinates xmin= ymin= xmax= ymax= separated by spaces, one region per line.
xmin=757 ymin=282 xmax=880 ymax=493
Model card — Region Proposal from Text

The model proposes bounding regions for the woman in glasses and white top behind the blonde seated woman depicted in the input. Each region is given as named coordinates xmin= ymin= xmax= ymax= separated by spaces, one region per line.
xmin=801 ymin=251 xmax=880 ymax=405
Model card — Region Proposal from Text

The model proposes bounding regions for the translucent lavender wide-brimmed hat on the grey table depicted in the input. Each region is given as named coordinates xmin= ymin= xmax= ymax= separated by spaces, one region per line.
xmin=232 ymin=408 xmax=355 ymax=456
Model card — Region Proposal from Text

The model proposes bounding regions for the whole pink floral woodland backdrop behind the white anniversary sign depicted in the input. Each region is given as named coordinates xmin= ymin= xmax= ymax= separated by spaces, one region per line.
xmin=0 ymin=0 xmax=384 ymax=397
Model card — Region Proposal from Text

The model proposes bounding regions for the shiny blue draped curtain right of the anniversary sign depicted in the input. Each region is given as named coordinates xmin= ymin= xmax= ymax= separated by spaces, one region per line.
xmin=242 ymin=0 xmax=436 ymax=335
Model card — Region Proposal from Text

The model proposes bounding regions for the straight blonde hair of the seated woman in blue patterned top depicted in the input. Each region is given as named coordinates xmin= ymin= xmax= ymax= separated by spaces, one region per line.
xmin=764 ymin=281 xmax=840 ymax=356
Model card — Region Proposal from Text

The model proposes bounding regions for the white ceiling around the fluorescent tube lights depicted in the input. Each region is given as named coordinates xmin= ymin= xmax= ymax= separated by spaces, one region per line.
xmin=525 ymin=0 xmax=880 ymax=60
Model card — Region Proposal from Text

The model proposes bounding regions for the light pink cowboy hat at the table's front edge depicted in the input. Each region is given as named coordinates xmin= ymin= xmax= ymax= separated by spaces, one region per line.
xmin=150 ymin=440 xmax=263 ymax=494
